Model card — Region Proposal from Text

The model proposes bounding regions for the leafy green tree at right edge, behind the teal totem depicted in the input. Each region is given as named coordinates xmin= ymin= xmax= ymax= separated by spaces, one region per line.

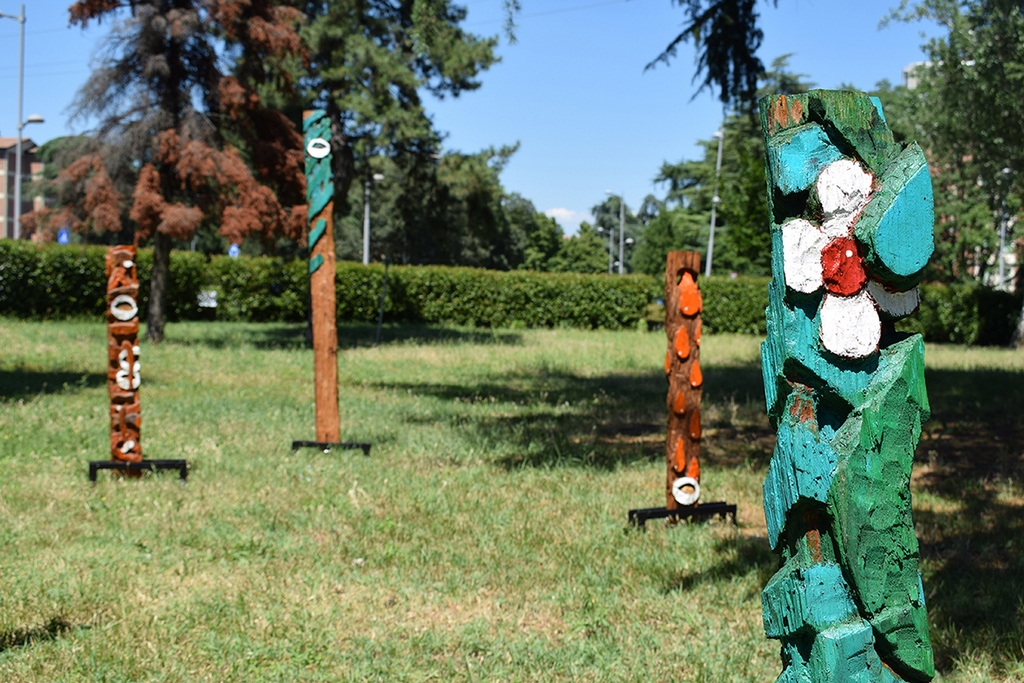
xmin=887 ymin=0 xmax=1024 ymax=345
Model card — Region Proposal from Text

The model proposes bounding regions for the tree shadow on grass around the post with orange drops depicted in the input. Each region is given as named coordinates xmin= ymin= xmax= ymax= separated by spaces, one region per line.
xmin=378 ymin=366 xmax=774 ymax=470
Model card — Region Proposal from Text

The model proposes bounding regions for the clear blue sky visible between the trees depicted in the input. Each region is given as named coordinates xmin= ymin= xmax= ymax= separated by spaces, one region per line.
xmin=0 ymin=0 xmax=931 ymax=232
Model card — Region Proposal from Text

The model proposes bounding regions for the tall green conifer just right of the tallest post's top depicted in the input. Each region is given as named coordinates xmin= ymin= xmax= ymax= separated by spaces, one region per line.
xmin=301 ymin=0 xmax=499 ymax=267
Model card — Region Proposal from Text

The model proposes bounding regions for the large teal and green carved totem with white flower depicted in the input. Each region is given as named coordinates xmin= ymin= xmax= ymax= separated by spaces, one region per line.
xmin=760 ymin=90 xmax=935 ymax=683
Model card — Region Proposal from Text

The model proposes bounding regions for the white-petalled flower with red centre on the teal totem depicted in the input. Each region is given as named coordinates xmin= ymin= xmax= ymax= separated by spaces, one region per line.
xmin=782 ymin=159 xmax=921 ymax=358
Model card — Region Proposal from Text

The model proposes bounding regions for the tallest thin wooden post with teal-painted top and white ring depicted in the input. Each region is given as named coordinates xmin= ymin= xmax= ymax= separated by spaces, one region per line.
xmin=302 ymin=110 xmax=341 ymax=442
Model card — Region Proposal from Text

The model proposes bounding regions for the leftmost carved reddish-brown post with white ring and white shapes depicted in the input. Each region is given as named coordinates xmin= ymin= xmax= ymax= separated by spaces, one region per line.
xmin=106 ymin=246 xmax=142 ymax=463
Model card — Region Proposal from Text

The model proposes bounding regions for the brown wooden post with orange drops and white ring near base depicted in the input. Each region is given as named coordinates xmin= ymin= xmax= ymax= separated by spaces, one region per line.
xmin=665 ymin=251 xmax=703 ymax=510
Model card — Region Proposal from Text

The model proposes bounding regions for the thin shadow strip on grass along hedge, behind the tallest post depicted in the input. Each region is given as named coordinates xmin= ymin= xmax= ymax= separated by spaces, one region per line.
xmin=165 ymin=323 xmax=522 ymax=349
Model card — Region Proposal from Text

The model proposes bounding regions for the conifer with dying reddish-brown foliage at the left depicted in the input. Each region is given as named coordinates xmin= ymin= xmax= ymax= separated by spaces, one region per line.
xmin=62 ymin=0 xmax=304 ymax=343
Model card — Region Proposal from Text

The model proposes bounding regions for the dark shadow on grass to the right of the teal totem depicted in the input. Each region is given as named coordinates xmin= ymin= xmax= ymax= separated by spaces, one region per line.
xmin=914 ymin=370 xmax=1024 ymax=672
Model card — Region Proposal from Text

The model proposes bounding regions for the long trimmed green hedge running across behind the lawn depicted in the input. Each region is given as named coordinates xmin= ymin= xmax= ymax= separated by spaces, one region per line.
xmin=0 ymin=240 xmax=1021 ymax=344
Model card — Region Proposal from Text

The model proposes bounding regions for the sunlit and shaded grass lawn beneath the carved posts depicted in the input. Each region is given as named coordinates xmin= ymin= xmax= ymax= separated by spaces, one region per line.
xmin=0 ymin=321 xmax=1024 ymax=683
